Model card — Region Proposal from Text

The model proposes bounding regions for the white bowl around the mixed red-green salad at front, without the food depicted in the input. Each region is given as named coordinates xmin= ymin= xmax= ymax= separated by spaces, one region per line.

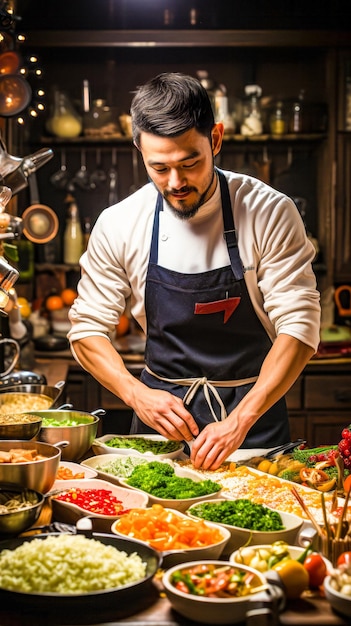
xmin=162 ymin=560 xmax=284 ymax=624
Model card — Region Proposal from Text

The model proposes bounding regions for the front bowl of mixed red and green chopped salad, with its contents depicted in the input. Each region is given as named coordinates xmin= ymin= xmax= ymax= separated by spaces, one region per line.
xmin=162 ymin=560 xmax=284 ymax=624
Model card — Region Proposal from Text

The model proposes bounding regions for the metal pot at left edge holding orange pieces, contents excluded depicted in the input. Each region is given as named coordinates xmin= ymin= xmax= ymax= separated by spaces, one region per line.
xmin=0 ymin=440 xmax=64 ymax=493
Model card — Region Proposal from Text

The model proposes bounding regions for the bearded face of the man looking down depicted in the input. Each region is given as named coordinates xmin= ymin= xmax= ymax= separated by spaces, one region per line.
xmin=140 ymin=124 xmax=223 ymax=219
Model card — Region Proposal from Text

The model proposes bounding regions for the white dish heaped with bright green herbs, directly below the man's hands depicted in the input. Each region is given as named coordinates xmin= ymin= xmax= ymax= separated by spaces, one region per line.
xmin=119 ymin=460 xmax=221 ymax=513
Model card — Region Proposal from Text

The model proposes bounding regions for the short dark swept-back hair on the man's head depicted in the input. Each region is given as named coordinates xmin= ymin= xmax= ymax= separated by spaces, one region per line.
xmin=130 ymin=72 xmax=214 ymax=146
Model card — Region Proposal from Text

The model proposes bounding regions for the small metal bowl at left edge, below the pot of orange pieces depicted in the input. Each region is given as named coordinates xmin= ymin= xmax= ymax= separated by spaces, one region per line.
xmin=0 ymin=483 xmax=45 ymax=535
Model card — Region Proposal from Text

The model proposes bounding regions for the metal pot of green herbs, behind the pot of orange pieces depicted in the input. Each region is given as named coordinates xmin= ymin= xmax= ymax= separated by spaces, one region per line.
xmin=31 ymin=409 xmax=105 ymax=461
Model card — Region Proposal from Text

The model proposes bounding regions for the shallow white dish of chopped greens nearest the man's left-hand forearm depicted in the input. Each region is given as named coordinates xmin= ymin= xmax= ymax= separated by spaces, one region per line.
xmin=92 ymin=435 xmax=184 ymax=459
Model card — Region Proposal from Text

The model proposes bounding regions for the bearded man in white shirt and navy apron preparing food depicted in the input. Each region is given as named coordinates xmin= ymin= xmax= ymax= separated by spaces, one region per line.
xmin=69 ymin=73 xmax=320 ymax=469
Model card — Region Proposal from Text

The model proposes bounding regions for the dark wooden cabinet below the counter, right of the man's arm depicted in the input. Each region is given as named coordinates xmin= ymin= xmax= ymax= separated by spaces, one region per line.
xmin=287 ymin=362 xmax=351 ymax=446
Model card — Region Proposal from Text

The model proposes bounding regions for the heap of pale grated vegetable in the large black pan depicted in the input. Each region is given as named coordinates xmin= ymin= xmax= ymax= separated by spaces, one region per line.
xmin=0 ymin=534 xmax=146 ymax=594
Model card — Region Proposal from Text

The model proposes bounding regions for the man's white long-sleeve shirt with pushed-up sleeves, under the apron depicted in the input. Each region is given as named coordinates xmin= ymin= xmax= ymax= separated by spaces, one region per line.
xmin=68 ymin=166 xmax=320 ymax=350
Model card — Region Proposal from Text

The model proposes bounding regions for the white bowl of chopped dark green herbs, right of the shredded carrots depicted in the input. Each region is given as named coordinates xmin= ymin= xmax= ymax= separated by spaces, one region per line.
xmin=186 ymin=498 xmax=303 ymax=554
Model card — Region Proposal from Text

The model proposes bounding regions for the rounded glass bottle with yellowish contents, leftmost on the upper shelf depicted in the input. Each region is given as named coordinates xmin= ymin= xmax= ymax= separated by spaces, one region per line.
xmin=46 ymin=90 xmax=82 ymax=139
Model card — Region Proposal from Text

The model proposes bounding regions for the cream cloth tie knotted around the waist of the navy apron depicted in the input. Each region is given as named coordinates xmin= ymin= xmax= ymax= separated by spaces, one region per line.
xmin=145 ymin=365 xmax=258 ymax=422
